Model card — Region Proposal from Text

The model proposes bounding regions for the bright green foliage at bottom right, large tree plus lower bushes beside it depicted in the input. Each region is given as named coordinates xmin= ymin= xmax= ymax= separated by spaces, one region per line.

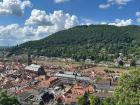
xmin=78 ymin=69 xmax=140 ymax=105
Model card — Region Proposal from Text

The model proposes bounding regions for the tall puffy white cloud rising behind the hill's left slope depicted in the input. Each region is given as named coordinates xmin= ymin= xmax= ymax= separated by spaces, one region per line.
xmin=25 ymin=9 xmax=78 ymax=34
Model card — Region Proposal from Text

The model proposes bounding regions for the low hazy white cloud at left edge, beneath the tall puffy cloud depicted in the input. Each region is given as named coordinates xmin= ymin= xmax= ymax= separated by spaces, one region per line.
xmin=0 ymin=24 xmax=52 ymax=46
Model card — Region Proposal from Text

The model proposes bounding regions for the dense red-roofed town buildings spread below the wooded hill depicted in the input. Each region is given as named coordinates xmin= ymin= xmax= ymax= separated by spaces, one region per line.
xmin=0 ymin=58 xmax=124 ymax=105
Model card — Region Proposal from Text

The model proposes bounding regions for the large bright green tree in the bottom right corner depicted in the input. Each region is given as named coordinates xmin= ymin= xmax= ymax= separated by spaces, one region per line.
xmin=114 ymin=70 xmax=140 ymax=105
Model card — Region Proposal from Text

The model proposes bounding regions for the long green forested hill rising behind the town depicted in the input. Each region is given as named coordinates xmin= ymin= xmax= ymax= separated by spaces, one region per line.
xmin=10 ymin=25 xmax=140 ymax=61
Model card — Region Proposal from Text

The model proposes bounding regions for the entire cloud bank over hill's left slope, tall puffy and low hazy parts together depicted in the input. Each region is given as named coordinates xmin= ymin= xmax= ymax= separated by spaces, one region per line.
xmin=0 ymin=10 xmax=79 ymax=46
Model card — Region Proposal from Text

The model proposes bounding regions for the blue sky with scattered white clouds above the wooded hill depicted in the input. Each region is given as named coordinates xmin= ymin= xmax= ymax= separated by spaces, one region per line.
xmin=0 ymin=0 xmax=140 ymax=46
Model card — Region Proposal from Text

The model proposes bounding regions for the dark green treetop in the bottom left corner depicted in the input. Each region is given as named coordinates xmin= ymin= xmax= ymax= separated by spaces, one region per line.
xmin=0 ymin=92 xmax=21 ymax=105
